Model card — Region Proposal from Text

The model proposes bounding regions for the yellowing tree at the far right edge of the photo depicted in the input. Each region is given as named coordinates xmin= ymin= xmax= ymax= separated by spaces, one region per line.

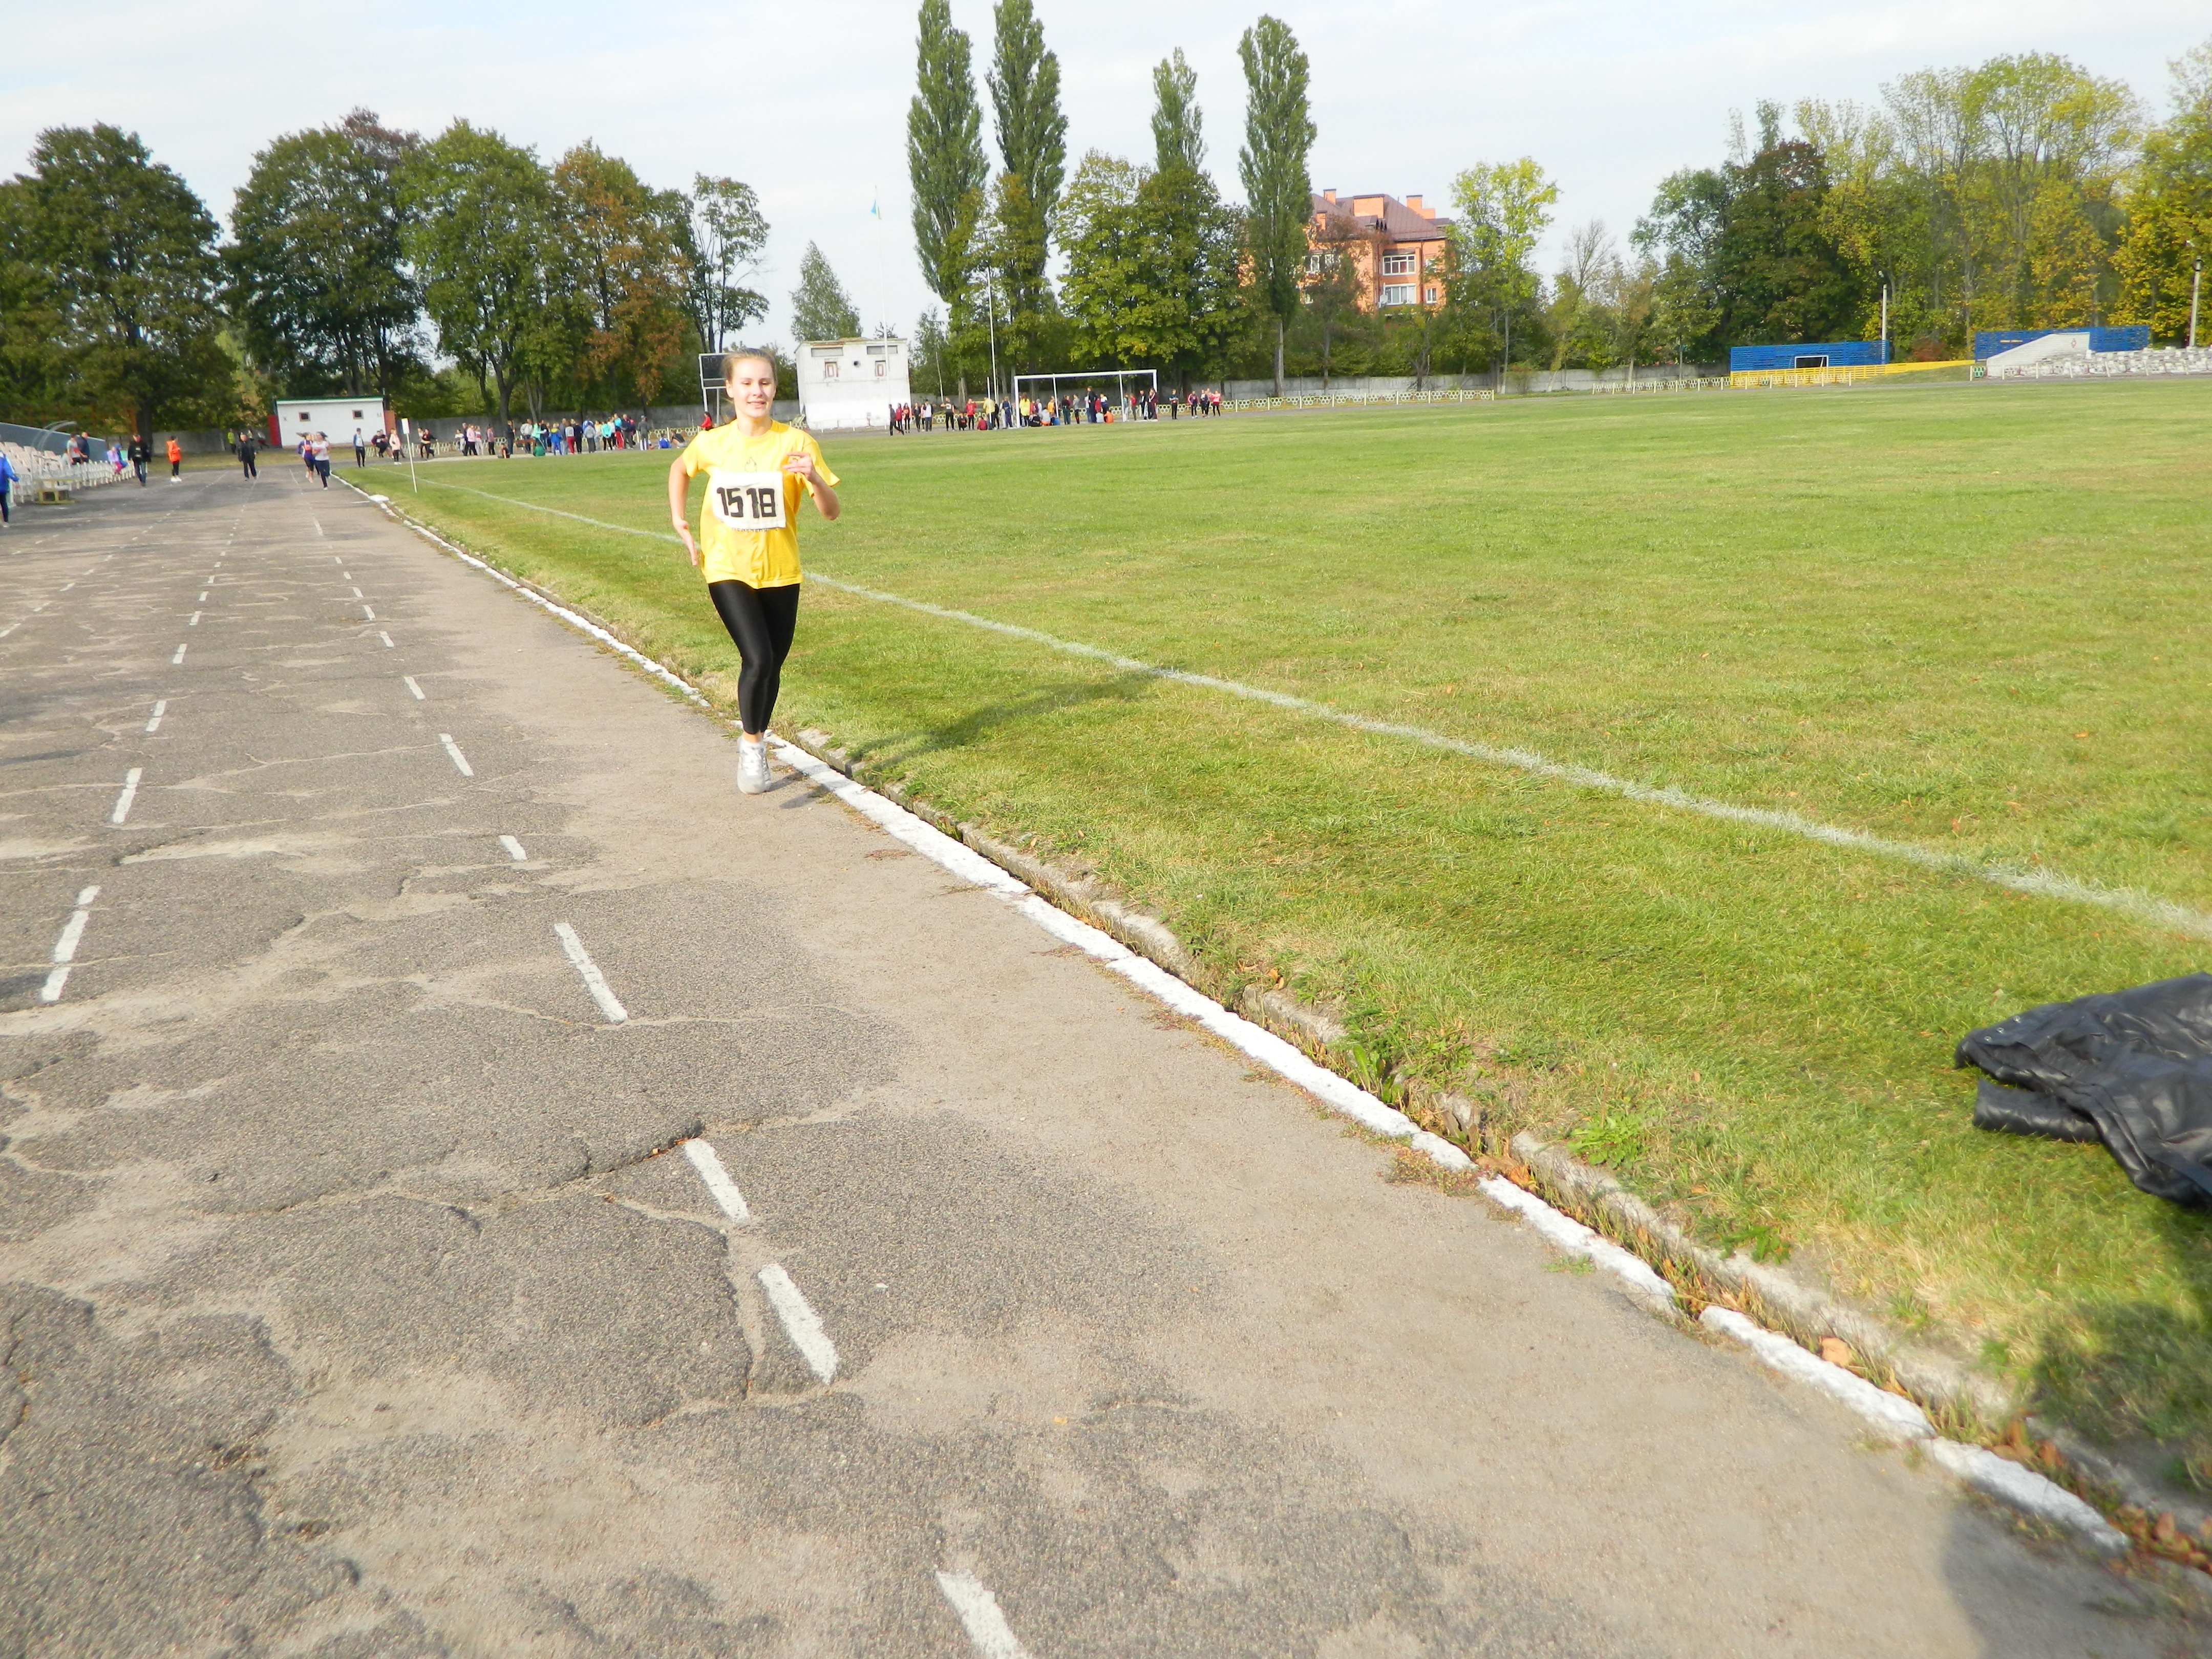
xmin=2117 ymin=40 xmax=2212 ymax=343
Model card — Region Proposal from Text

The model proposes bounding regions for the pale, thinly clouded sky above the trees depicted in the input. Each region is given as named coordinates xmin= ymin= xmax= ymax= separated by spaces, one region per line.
xmin=0 ymin=0 xmax=2212 ymax=358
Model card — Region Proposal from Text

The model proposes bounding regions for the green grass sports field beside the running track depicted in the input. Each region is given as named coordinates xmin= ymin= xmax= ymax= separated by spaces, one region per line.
xmin=354 ymin=382 xmax=2212 ymax=1484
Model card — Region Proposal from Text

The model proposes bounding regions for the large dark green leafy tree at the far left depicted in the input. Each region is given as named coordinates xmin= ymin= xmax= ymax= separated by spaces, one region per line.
xmin=13 ymin=124 xmax=239 ymax=436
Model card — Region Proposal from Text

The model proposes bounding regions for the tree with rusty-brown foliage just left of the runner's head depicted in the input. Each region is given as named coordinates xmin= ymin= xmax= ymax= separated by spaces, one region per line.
xmin=553 ymin=144 xmax=688 ymax=407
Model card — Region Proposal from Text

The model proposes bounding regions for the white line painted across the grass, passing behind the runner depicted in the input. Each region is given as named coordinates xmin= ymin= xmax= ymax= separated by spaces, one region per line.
xmin=380 ymin=480 xmax=2212 ymax=940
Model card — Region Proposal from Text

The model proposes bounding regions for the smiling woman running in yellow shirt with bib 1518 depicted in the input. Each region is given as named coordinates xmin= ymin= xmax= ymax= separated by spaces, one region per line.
xmin=668 ymin=352 xmax=838 ymax=794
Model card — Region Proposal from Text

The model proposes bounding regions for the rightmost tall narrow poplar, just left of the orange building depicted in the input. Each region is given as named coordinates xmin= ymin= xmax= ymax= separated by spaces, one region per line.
xmin=1237 ymin=15 xmax=1314 ymax=396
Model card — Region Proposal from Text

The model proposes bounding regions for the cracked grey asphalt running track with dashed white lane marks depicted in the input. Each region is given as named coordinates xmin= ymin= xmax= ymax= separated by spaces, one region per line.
xmin=0 ymin=462 xmax=2190 ymax=1659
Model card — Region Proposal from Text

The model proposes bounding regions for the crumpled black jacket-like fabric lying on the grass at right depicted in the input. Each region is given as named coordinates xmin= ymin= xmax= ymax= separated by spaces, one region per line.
xmin=1955 ymin=973 xmax=2212 ymax=1208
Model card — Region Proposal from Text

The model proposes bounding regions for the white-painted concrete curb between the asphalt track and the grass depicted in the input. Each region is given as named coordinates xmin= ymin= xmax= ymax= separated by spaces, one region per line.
xmin=354 ymin=486 xmax=2159 ymax=1553
